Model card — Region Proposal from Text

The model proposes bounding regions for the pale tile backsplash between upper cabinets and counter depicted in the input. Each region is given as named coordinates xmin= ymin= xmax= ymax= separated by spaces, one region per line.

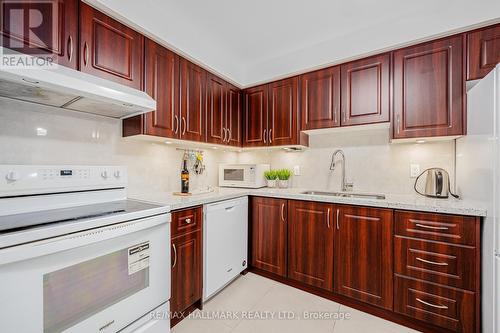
xmin=0 ymin=98 xmax=455 ymax=195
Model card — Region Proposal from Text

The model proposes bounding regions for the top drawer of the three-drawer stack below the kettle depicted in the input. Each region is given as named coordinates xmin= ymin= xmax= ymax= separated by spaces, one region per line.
xmin=395 ymin=211 xmax=478 ymax=246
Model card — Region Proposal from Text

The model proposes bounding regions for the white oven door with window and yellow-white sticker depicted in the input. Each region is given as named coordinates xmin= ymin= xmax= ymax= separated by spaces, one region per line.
xmin=0 ymin=214 xmax=170 ymax=333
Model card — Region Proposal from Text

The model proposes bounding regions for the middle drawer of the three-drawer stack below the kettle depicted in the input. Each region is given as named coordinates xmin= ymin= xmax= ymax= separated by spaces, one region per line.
xmin=394 ymin=236 xmax=476 ymax=291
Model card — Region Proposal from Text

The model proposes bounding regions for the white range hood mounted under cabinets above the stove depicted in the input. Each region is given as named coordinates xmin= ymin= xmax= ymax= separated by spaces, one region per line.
xmin=0 ymin=47 xmax=156 ymax=119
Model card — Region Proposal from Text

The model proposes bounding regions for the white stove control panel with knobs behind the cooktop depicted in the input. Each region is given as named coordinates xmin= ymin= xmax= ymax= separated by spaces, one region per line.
xmin=0 ymin=165 xmax=127 ymax=197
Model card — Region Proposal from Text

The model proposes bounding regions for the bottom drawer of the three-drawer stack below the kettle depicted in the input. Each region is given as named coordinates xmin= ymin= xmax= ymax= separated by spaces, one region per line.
xmin=394 ymin=275 xmax=476 ymax=333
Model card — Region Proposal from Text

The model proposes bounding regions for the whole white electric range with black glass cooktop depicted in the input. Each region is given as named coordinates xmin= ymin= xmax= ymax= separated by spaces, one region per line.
xmin=0 ymin=165 xmax=171 ymax=333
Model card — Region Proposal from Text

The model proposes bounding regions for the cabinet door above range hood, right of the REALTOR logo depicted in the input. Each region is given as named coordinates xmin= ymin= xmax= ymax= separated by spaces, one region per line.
xmin=80 ymin=2 xmax=144 ymax=89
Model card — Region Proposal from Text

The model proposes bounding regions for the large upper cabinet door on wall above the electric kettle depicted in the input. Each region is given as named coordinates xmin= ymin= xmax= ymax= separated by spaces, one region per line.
xmin=393 ymin=35 xmax=465 ymax=139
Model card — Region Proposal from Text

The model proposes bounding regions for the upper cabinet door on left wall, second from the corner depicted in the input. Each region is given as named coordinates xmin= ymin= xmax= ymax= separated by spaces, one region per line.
xmin=207 ymin=74 xmax=228 ymax=144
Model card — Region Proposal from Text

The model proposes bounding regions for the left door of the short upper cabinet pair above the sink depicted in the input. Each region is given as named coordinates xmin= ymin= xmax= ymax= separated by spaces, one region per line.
xmin=300 ymin=66 xmax=340 ymax=131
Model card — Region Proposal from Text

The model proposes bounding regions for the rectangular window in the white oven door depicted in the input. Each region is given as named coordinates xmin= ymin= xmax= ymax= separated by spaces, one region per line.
xmin=43 ymin=244 xmax=149 ymax=333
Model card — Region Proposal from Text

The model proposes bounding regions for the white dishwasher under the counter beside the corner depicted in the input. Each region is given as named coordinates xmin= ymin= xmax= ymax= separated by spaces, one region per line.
xmin=203 ymin=197 xmax=248 ymax=301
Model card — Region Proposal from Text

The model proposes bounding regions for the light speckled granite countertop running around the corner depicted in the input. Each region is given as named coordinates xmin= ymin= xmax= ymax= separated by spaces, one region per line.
xmin=132 ymin=188 xmax=486 ymax=216
